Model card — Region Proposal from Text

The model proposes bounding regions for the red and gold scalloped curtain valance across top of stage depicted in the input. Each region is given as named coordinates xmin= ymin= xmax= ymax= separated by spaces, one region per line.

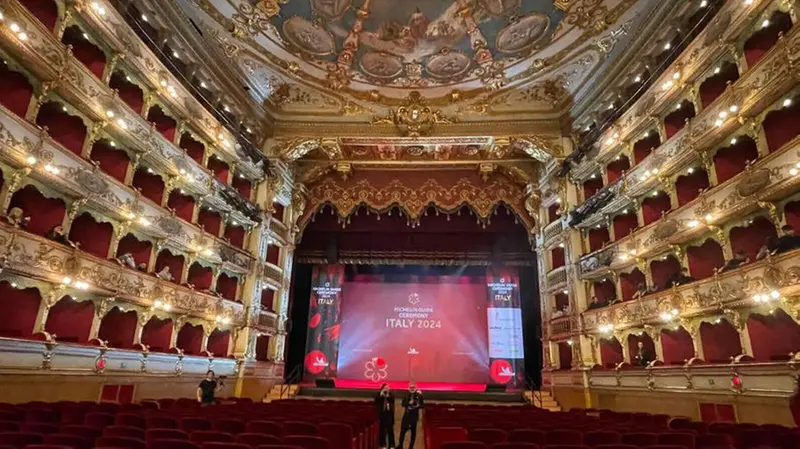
xmin=297 ymin=170 xmax=538 ymax=240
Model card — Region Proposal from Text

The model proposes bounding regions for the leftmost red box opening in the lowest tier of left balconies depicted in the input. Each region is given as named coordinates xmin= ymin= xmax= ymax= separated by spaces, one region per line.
xmin=0 ymin=281 xmax=42 ymax=338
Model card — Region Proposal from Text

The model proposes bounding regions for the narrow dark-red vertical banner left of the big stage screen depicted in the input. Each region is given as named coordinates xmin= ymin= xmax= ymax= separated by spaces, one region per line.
xmin=304 ymin=265 xmax=344 ymax=380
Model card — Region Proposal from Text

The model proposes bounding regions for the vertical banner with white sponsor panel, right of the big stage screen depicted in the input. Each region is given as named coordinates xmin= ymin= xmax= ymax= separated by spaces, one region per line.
xmin=486 ymin=267 xmax=525 ymax=388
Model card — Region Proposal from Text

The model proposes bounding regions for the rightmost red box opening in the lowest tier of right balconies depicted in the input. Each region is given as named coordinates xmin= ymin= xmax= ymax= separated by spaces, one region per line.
xmin=747 ymin=309 xmax=800 ymax=362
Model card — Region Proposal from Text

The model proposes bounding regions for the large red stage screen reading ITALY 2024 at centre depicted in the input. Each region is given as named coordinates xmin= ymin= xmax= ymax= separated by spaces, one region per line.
xmin=338 ymin=276 xmax=490 ymax=383
